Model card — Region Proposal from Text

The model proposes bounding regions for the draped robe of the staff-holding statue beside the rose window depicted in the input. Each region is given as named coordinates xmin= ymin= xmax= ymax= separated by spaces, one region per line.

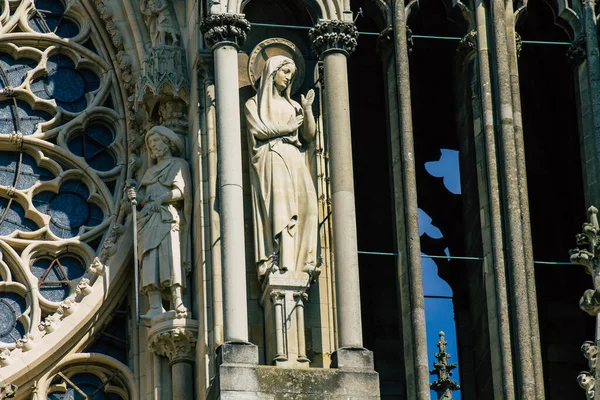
xmin=138 ymin=157 xmax=192 ymax=291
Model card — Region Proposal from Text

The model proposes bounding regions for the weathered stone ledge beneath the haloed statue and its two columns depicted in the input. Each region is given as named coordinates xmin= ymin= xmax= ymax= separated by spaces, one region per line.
xmin=208 ymin=365 xmax=380 ymax=400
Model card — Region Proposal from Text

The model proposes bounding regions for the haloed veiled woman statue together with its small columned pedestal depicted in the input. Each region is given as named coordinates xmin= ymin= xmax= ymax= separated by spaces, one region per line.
xmin=245 ymin=38 xmax=319 ymax=368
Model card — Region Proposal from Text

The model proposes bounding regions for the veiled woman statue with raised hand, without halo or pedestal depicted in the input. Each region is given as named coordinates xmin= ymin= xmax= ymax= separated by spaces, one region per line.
xmin=245 ymin=55 xmax=318 ymax=279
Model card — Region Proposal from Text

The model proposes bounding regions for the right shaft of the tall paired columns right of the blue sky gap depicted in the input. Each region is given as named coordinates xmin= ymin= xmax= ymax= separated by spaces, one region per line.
xmin=488 ymin=0 xmax=543 ymax=399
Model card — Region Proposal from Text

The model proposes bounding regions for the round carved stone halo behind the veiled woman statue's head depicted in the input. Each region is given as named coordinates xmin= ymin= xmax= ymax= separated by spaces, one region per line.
xmin=248 ymin=38 xmax=306 ymax=94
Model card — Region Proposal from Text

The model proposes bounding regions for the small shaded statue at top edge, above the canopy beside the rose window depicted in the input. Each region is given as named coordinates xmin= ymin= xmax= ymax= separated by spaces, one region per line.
xmin=140 ymin=0 xmax=179 ymax=47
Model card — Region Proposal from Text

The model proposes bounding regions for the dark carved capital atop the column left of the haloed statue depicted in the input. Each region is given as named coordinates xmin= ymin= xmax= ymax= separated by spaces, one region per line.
xmin=200 ymin=14 xmax=250 ymax=49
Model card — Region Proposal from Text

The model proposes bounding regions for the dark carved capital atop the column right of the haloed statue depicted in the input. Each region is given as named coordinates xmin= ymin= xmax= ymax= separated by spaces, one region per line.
xmin=308 ymin=20 xmax=358 ymax=57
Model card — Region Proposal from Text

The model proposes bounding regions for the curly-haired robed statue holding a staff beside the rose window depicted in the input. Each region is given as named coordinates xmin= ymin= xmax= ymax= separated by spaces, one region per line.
xmin=127 ymin=126 xmax=192 ymax=321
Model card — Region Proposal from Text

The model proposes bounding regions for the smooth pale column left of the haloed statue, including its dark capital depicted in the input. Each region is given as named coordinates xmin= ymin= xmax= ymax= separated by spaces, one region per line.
xmin=200 ymin=14 xmax=250 ymax=342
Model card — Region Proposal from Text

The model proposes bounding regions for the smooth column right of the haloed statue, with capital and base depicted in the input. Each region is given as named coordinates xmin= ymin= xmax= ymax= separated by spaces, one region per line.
xmin=309 ymin=21 xmax=372 ymax=368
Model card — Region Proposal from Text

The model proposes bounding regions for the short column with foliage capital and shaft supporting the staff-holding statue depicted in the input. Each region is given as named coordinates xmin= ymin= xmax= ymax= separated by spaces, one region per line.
xmin=148 ymin=320 xmax=198 ymax=400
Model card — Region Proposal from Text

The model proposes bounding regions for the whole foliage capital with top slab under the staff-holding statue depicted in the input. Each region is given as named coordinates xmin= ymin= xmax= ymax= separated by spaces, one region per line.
xmin=148 ymin=319 xmax=198 ymax=365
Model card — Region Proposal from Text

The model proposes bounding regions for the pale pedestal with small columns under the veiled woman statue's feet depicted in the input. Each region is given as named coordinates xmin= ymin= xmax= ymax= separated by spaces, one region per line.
xmin=261 ymin=270 xmax=311 ymax=368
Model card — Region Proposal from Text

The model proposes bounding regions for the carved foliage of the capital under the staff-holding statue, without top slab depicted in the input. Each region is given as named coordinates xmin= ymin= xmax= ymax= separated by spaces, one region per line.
xmin=148 ymin=327 xmax=196 ymax=364
